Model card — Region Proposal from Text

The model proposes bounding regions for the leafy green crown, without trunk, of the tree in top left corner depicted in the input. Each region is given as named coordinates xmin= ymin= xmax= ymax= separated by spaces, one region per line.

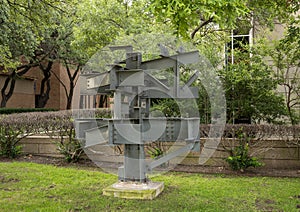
xmin=0 ymin=0 xmax=71 ymax=70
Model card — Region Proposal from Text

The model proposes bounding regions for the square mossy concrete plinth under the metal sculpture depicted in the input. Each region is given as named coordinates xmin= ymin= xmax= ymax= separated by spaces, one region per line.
xmin=103 ymin=182 xmax=164 ymax=200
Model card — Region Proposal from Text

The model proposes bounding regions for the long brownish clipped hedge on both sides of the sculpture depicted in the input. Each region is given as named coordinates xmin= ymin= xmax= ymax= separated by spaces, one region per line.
xmin=0 ymin=109 xmax=300 ymax=157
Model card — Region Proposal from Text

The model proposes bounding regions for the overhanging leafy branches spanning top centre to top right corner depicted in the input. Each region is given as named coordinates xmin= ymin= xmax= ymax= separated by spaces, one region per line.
xmin=149 ymin=0 xmax=299 ymax=40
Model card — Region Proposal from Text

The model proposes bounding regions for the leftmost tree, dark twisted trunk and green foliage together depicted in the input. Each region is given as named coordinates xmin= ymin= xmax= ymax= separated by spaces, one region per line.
xmin=0 ymin=0 xmax=66 ymax=107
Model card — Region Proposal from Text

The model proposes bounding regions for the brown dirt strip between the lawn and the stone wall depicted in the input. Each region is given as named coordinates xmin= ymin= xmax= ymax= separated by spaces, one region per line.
xmin=0 ymin=155 xmax=300 ymax=177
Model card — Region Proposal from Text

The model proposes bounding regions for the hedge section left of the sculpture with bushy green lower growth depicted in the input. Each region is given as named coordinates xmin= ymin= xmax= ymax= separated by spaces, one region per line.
xmin=0 ymin=109 xmax=111 ymax=162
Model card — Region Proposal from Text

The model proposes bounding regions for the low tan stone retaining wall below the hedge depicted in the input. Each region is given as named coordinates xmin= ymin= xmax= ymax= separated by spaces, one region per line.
xmin=21 ymin=136 xmax=300 ymax=169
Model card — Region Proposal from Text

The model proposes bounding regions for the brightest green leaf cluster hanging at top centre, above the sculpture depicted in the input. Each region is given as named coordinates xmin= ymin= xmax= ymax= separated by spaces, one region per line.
xmin=149 ymin=0 xmax=250 ymax=38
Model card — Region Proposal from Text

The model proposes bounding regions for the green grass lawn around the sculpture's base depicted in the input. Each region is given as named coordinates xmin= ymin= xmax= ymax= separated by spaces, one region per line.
xmin=0 ymin=162 xmax=300 ymax=212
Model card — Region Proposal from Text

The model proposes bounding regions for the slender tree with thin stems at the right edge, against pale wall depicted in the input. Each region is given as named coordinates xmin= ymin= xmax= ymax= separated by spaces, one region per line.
xmin=270 ymin=17 xmax=300 ymax=125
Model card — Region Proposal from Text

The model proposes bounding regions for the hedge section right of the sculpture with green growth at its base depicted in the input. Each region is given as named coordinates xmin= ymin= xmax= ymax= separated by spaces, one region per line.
xmin=200 ymin=124 xmax=300 ymax=170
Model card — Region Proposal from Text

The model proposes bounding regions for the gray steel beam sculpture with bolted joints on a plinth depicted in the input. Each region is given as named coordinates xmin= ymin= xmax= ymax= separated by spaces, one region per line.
xmin=75 ymin=46 xmax=200 ymax=182
